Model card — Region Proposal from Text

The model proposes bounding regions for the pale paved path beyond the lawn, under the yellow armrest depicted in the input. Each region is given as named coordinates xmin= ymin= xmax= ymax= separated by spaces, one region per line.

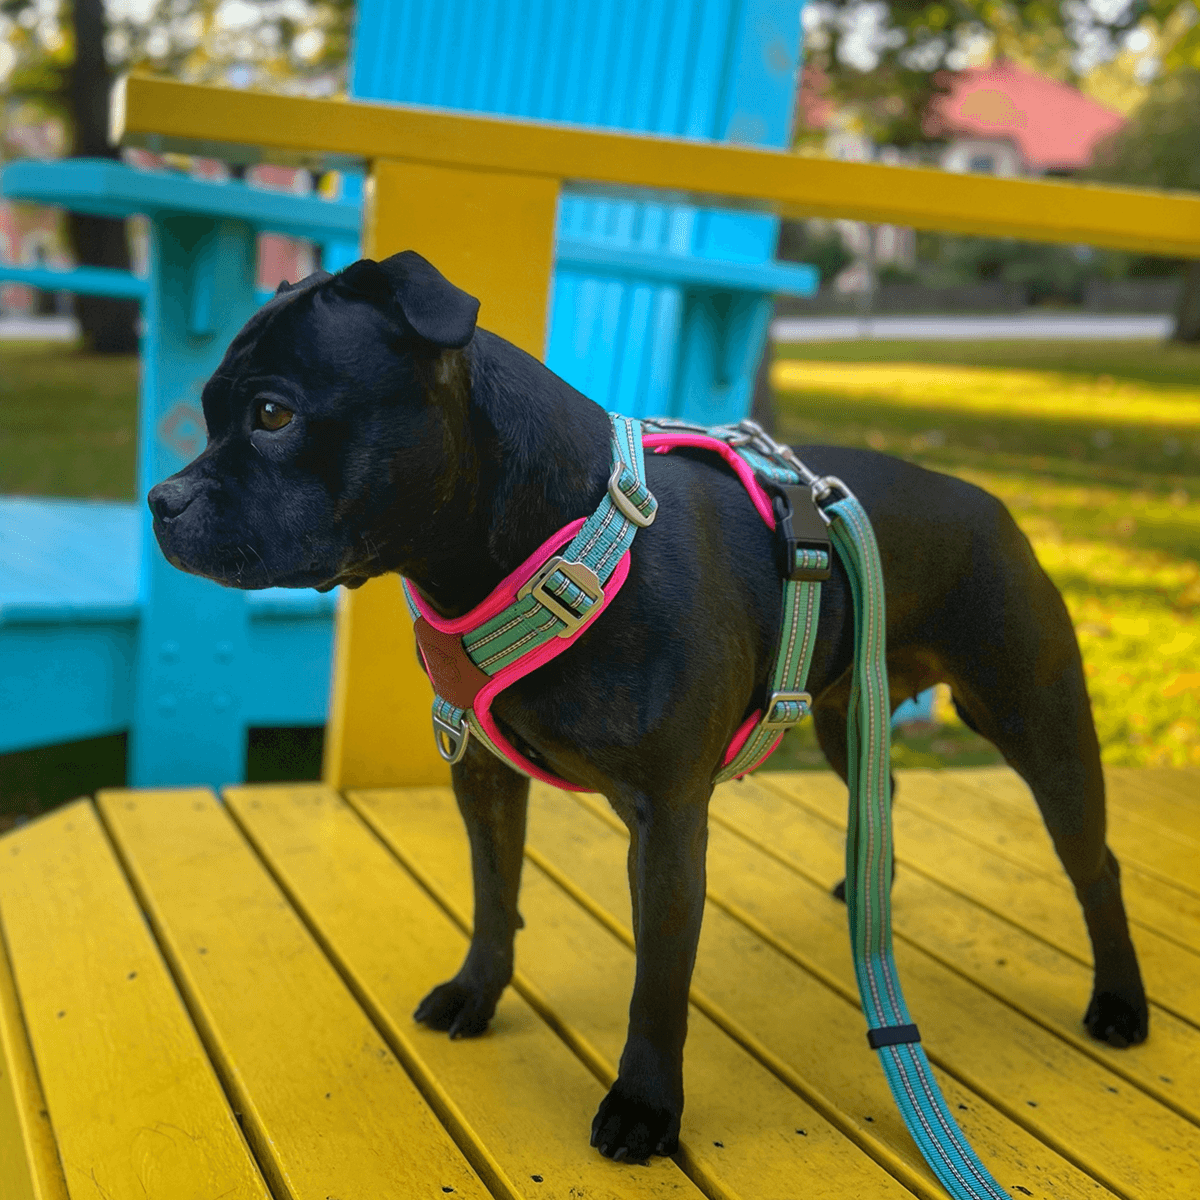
xmin=770 ymin=313 xmax=1171 ymax=342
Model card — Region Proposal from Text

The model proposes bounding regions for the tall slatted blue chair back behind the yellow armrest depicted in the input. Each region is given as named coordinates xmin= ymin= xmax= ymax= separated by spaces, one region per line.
xmin=350 ymin=0 xmax=816 ymax=421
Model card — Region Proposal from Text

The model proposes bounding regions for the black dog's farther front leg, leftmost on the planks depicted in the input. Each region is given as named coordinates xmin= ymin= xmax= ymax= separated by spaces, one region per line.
xmin=413 ymin=739 xmax=529 ymax=1038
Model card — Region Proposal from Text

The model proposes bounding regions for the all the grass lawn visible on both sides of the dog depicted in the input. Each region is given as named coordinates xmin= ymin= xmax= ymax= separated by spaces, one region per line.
xmin=0 ymin=341 xmax=1200 ymax=809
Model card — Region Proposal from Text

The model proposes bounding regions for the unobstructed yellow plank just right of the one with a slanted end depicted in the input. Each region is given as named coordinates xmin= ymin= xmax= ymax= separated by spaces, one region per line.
xmin=98 ymin=791 xmax=487 ymax=1200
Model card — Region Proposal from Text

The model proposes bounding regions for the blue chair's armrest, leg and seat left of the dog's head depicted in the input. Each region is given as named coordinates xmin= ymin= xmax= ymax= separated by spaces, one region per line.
xmin=0 ymin=160 xmax=359 ymax=786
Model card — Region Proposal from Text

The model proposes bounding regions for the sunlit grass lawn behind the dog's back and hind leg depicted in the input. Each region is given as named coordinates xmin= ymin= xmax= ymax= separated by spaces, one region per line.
xmin=772 ymin=341 xmax=1200 ymax=766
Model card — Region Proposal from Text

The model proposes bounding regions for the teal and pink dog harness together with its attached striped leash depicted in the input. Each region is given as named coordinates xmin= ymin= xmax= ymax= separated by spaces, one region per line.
xmin=404 ymin=415 xmax=1008 ymax=1200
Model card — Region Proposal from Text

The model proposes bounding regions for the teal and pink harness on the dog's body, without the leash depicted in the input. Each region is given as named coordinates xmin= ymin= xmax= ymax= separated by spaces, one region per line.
xmin=404 ymin=413 xmax=832 ymax=791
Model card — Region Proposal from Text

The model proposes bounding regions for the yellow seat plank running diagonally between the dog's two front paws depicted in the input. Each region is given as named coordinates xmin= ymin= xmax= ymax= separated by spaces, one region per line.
xmin=348 ymin=790 xmax=916 ymax=1200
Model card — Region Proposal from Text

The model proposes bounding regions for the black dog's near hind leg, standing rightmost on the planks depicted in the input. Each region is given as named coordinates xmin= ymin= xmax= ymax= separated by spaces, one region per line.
xmin=950 ymin=592 xmax=1148 ymax=1046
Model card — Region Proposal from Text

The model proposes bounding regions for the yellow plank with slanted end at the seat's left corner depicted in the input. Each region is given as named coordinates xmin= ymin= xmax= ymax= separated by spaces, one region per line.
xmin=0 ymin=800 xmax=268 ymax=1200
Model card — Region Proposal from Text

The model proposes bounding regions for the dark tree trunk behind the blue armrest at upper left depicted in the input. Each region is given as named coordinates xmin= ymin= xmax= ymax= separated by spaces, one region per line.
xmin=67 ymin=0 xmax=139 ymax=354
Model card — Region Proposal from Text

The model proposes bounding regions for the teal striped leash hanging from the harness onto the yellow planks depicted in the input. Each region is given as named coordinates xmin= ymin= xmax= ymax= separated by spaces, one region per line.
xmin=826 ymin=481 xmax=1008 ymax=1200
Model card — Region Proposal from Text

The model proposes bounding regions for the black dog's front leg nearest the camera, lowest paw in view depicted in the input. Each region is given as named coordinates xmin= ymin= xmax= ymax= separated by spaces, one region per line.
xmin=592 ymin=790 xmax=708 ymax=1160
